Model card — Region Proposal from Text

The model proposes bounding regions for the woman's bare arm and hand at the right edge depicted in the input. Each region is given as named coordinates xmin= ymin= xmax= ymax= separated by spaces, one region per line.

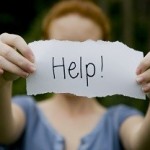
xmin=120 ymin=53 xmax=150 ymax=150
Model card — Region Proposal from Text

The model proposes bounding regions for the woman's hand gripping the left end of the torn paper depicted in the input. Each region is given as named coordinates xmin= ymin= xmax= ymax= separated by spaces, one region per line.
xmin=0 ymin=33 xmax=36 ymax=84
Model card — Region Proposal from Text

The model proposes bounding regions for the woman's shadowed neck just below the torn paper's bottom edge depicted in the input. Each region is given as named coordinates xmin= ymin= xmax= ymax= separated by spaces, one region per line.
xmin=50 ymin=94 xmax=103 ymax=116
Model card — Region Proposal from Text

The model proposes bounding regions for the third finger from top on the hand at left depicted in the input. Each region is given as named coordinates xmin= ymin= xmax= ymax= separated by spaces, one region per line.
xmin=0 ymin=56 xmax=29 ymax=78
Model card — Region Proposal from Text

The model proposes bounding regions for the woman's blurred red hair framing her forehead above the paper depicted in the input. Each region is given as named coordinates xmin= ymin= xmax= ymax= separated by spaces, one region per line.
xmin=42 ymin=0 xmax=110 ymax=40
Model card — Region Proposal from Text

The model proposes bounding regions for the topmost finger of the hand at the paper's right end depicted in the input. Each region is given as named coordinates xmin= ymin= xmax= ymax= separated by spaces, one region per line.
xmin=136 ymin=52 xmax=150 ymax=75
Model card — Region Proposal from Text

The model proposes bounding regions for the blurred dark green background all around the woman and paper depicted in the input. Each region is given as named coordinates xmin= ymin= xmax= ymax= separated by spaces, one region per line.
xmin=0 ymin=0 xmax=150 ymax=113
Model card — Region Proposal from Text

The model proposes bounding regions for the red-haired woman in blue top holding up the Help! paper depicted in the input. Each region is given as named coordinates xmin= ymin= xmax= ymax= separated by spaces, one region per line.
xmin=0 ymin=1 xmax=150 ymax=150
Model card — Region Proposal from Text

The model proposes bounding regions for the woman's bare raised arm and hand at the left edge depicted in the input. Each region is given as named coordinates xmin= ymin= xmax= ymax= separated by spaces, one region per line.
xmin=0 ymin=33 xmax=35 ymax=144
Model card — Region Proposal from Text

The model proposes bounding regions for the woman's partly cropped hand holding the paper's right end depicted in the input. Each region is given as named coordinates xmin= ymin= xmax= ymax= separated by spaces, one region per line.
xmin=136 ymin=52 xmax=150 ymax=98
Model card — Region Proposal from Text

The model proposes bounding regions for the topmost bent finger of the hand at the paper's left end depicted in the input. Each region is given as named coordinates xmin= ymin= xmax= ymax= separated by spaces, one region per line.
xmin=0 ymin=33 xmax=34 ymax=62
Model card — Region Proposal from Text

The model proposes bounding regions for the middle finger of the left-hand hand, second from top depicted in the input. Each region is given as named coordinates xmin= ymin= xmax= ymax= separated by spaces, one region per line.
xmin=0 ymin=43 xmax=35 ymax=73
